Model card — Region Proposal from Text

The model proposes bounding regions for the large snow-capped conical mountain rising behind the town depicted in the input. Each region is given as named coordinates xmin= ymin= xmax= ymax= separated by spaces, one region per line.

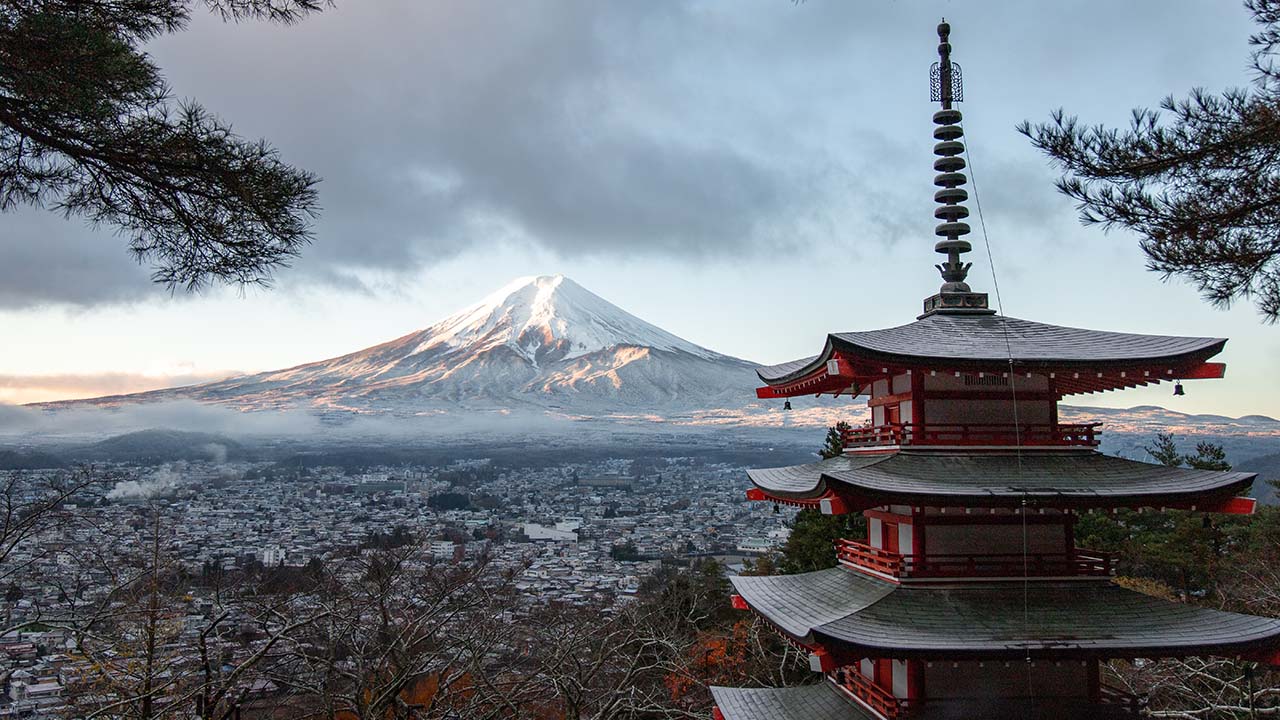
xmin=80 ymin=275 xmax=756 ymax=415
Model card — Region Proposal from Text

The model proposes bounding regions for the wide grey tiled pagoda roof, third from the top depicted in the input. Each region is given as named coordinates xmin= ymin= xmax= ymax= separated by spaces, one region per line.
xmin=731 ymin=568 xmax=1280 ymax=657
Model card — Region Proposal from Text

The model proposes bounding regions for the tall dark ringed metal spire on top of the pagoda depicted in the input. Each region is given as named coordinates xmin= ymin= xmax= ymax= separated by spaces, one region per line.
xmin=924 ymin=18 xmax=991 ymax=315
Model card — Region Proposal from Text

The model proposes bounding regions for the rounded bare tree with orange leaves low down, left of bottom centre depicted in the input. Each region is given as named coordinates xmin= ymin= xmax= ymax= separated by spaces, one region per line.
xmin=273 ymin=547 xmax=513 ymax=720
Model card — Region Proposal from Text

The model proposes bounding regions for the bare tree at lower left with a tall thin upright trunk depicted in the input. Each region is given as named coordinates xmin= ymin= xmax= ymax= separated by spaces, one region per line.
xmin=68 ymin=509 xmax=323 ymax=720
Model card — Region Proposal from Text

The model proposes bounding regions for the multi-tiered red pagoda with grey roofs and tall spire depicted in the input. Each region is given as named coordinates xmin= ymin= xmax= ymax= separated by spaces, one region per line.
xmin=712 ymin=22 xmax=1280 ymax=720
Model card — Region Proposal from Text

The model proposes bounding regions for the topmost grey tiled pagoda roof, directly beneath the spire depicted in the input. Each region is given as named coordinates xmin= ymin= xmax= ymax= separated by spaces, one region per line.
xmin=756 ymin=315 xmax=1226 ymax=383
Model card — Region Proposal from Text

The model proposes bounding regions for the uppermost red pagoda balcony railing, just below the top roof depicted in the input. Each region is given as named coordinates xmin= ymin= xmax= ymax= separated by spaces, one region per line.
xmin=844 ymin=423 xmax=1102 ymax=450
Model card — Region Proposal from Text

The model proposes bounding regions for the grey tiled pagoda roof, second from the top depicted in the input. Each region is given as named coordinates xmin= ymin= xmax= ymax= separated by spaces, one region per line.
xmin=748 ymin=450 xmax=1257 ymax=506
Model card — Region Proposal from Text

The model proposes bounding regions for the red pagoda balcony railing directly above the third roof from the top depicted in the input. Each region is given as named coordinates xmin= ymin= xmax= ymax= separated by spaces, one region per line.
xmin=836 ymin=539 xmax=1116 ymax=580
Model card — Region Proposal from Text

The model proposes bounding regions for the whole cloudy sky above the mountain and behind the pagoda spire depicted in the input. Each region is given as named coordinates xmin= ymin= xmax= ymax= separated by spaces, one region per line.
xmin=0 ymin=0 xmax=1280 ymax=415
